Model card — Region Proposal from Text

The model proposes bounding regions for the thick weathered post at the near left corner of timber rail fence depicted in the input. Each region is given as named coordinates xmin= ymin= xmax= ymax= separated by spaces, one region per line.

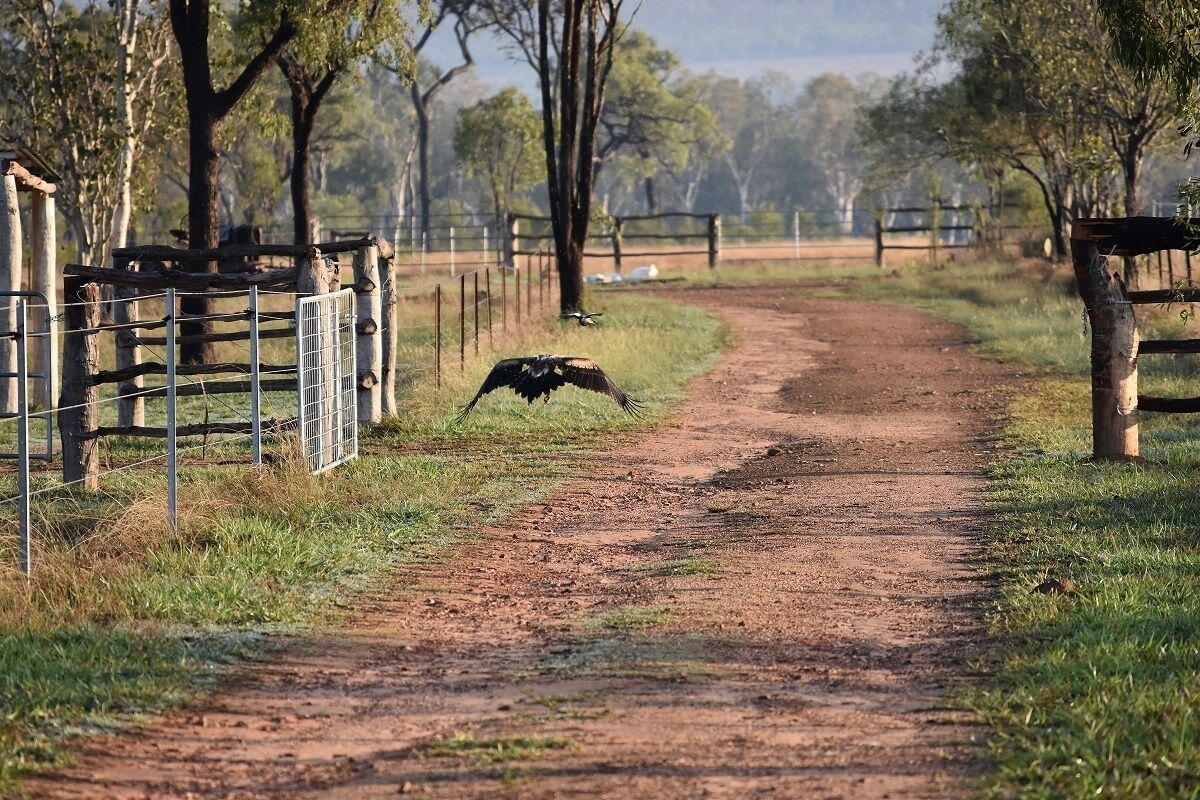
xmin=59 ymin=277 xmax=100 ymax=491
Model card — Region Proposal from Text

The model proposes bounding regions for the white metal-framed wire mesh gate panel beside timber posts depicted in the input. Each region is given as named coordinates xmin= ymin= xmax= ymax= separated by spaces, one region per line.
xmin=296 ymin=289 xmax=359 ymax=475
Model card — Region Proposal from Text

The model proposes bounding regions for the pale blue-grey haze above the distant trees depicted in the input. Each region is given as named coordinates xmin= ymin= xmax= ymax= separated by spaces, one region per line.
xmin=430 ymin=0 xmax=943 ymax=89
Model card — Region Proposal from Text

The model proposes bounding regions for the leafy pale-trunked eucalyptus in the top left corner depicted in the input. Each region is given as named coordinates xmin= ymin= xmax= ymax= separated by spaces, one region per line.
xmin=0 ymin=0 xmax=174 ymax=264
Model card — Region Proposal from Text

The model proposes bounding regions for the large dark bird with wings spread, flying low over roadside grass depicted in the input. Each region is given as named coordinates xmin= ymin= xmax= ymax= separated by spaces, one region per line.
xmin=457 ymin=355 xmax=643 ymax=422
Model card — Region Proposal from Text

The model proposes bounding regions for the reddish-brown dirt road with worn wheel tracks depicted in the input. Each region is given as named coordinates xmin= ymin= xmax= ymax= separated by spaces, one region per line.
xmin=29 ymin=289 xmax=1004 ymax=800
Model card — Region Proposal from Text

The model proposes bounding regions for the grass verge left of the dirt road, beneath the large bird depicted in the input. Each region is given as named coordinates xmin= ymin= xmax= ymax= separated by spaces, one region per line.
xmin=0 ymin=291 xmax=727 ymax=793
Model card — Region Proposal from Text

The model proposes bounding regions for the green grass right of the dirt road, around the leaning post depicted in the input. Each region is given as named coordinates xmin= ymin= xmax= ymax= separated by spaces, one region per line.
xmin=825 ymin=264 xmax=1200 ymax=799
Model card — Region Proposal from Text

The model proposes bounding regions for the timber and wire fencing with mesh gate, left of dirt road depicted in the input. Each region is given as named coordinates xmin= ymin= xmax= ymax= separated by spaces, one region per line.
xmin=0 ymin=236 xmax=557 ymax=573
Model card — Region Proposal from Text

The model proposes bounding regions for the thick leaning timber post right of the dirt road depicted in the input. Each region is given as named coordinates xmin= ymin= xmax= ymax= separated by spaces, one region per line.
xmin=1070 ymin=239 xmax=1139 ymax=461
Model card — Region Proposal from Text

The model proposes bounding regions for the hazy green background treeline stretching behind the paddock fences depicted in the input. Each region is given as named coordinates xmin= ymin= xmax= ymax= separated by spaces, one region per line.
xmin=0 ymin=0 xmax=1182 ymax=260
